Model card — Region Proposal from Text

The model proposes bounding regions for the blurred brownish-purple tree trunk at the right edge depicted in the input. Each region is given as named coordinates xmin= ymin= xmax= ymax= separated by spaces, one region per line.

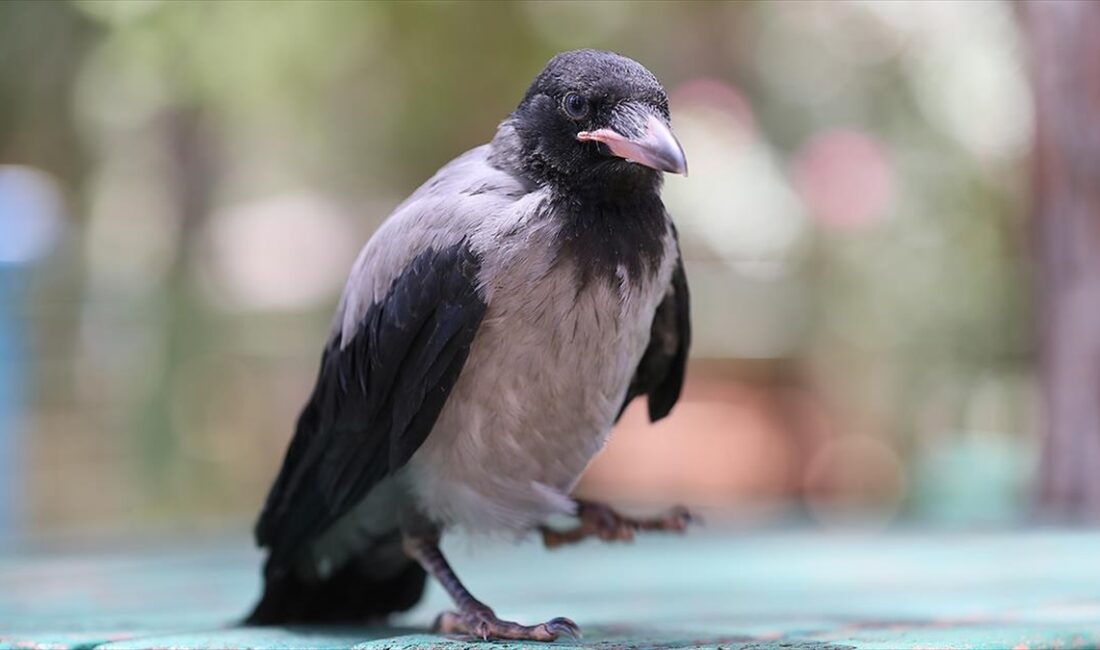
xmin=1025 ymin=0 xmax=1100 ymax=520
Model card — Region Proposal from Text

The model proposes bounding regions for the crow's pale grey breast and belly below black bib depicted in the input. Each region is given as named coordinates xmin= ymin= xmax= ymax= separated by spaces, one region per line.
xmin=409 ymin=211 xmax=675 ymax=532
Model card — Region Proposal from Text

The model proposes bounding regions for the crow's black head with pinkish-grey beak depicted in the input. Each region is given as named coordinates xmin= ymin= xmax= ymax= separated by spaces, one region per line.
xmin=506 ymin=49 xmax=688 ymax=194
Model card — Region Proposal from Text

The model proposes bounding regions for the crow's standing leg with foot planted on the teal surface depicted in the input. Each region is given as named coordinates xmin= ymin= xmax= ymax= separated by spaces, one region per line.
xmin=405 ymin=537 xmax=581 ymax=641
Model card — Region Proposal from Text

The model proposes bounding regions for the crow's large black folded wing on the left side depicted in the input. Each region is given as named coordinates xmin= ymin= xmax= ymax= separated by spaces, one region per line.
xmin=255 ymin=244 xmax=485 ymax=574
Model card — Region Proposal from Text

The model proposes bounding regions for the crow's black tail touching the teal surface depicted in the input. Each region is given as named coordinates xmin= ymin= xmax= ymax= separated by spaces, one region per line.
xmin=244 ymin=554 xmax=427 ymax=625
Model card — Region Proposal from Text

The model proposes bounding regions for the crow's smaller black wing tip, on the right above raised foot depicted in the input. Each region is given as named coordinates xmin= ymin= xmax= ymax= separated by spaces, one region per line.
xmin=619 ymin=247 xmax=691 ymax=422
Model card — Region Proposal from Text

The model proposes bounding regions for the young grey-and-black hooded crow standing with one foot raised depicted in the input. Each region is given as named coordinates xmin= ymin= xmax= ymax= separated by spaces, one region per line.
xmin=248 ymin=49 xmax=690 ymax=640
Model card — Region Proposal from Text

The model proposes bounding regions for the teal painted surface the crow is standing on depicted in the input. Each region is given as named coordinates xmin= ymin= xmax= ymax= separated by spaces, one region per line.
xmin=0 ymin=528 xmax=1100 ymax=650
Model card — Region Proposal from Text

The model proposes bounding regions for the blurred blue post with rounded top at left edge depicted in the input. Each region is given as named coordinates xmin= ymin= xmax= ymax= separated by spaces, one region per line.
xmin=0 ymin=166 xmax=63 ymax=539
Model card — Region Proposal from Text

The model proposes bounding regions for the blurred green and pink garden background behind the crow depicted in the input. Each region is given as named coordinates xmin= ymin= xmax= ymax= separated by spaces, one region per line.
xmin=0 ymin=0 xmax=1100 ymax=543
